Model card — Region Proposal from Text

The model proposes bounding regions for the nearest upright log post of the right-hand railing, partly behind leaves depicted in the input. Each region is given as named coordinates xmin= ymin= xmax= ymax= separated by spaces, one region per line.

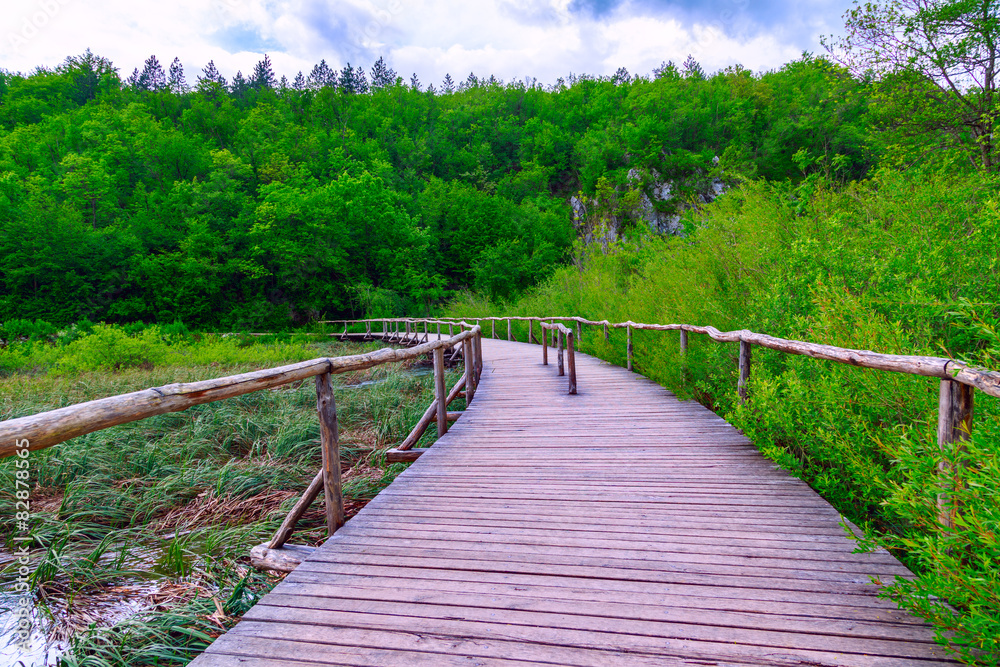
xmin=938 ymin=380 xmax=972 ymax=530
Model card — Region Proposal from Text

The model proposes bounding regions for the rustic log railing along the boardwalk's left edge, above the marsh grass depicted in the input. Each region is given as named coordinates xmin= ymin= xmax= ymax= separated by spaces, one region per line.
xmin=0 ymin=321 xmax=482 ymax=569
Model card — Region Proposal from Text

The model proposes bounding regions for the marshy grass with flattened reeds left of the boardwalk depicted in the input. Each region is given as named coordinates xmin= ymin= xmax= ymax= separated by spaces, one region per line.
xmin=0 ymin=327 xmax=457 ymax=665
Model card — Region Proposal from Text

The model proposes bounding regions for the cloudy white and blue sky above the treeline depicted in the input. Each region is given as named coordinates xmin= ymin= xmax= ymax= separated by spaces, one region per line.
xmin=0 ymin=0 xmax=850 ymax=86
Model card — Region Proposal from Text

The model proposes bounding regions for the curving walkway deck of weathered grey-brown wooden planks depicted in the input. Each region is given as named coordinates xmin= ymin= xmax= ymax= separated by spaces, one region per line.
xmin=192 ymin=339 xmax=955 ymax=667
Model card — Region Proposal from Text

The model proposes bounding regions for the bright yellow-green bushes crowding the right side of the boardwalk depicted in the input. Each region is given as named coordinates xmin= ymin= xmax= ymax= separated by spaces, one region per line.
xmin=451 ymin=168 xmax=1000 ymax=665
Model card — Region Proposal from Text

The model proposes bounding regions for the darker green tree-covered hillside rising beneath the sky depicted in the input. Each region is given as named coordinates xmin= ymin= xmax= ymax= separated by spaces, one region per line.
xmin=0 ymin=52 xmax=878 ymax=328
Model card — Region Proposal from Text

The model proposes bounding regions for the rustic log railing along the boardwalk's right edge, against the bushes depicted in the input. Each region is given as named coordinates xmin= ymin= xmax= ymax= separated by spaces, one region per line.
xmin=432 ymin=316 xmax=1000 ymax=528
